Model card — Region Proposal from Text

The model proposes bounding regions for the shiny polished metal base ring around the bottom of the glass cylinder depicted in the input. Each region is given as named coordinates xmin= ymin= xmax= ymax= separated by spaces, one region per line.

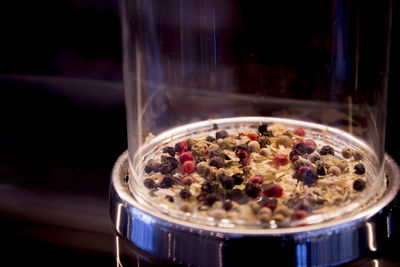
xmin=110 ymin=152 xmax=400 ymax=266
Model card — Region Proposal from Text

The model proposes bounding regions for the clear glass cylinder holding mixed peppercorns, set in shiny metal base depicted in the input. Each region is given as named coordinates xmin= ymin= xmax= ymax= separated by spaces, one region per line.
xmin=121 ymin=0 xmax=391 ymax=228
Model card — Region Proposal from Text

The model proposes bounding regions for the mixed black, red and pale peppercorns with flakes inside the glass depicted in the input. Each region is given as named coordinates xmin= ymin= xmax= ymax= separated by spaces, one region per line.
xmin=143 ymin=123 xmax=368 ymax=224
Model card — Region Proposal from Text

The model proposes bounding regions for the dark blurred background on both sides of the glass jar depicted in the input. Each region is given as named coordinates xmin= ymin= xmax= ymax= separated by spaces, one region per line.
xmin=0 ymin=0 xmax=400 ymax=266
